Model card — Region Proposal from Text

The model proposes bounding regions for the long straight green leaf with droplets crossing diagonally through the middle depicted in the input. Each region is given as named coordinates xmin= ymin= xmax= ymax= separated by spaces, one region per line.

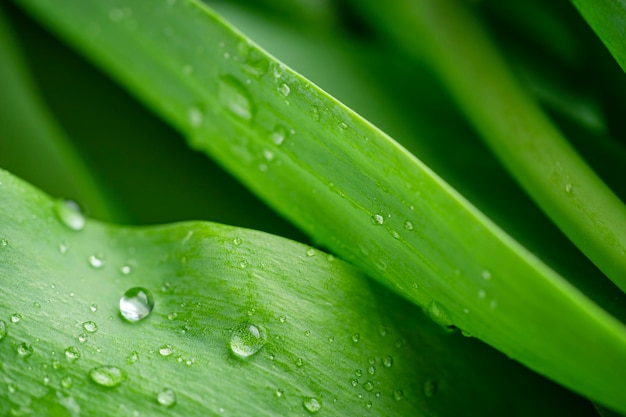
xmin=13 ymin=0 xmax=626 ymax=411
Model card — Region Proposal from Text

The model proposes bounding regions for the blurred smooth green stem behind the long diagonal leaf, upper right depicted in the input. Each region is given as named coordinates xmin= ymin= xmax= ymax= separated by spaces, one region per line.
xmin=354 ymin=0 xmax=626 ymax=291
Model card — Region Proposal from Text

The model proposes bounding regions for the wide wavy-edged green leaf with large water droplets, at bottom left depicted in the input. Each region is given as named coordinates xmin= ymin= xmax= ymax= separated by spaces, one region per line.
xmin=0 ymin=167 xmax=590 ymax=417
